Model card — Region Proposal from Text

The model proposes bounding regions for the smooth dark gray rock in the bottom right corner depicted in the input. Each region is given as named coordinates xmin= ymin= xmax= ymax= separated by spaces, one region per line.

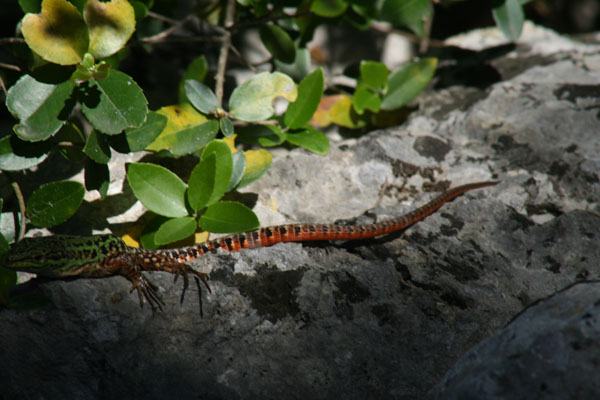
xmin=431 ymin=282 xmax=600 ymax=400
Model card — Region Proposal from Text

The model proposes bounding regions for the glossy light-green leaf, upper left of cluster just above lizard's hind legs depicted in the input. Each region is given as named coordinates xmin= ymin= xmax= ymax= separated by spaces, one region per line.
xmin=127 ymin=163 xmax=188 ymax=218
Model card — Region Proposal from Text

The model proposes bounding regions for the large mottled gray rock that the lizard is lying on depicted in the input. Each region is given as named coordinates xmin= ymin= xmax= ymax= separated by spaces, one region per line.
xmin=0 ymin=25 xmax=600 ymax=399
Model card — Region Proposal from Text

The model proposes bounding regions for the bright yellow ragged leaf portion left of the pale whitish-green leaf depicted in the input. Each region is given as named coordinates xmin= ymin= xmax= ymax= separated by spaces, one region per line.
xmin=146 ymin=103 xmax=207 ymax=151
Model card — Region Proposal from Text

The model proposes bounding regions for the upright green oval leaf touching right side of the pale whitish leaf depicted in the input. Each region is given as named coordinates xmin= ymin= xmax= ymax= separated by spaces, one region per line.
xmin=283 ymin=68 xmax=325 ymax=129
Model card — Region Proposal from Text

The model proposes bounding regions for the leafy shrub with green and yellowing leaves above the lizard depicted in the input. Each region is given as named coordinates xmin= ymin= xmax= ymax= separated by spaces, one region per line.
xmin=0 ymin=0 xmax=526 ymax=253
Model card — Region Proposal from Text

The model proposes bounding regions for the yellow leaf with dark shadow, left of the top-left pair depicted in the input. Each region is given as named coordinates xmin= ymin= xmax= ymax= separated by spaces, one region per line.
xmin=21 ymin=0 xmax=89 ymax=65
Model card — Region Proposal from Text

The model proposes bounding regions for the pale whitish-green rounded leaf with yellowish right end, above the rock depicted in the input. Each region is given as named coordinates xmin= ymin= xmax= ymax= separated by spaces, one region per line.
xmin=229 ymin=72 xmax=298 ymax=122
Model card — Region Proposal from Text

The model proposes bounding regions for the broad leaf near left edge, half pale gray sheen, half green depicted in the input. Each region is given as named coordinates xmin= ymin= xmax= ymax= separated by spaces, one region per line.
xmin=6 ymin=75 xmax=75 ymax=142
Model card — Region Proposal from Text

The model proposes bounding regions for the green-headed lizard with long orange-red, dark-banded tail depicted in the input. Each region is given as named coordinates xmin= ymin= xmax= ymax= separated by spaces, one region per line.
xmin=0 ymin=181 xmax=498 ymax=312
